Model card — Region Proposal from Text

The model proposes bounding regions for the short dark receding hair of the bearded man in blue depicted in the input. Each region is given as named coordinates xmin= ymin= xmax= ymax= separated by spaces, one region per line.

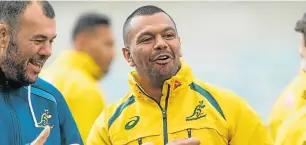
xmin=0 ymin=0 xmax=55 ymax=33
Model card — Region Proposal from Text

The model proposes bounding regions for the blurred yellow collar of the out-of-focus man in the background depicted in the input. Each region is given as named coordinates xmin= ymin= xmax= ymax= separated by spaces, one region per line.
xmin=55 ymin=50 xmax=103 ymax=78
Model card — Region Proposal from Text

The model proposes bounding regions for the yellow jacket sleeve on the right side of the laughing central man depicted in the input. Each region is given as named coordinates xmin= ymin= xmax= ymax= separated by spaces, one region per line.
xmin=230 ymin=99 xmax=274 ymax=145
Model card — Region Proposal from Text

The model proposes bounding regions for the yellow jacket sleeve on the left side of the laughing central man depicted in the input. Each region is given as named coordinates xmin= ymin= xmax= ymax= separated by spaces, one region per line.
xmin=86 ymin=109 xmax=112 ymax=145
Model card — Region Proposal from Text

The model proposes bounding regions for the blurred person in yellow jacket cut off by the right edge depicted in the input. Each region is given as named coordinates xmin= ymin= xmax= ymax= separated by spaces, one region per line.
xmin=268 ymin=13 xmax=306 ymax=139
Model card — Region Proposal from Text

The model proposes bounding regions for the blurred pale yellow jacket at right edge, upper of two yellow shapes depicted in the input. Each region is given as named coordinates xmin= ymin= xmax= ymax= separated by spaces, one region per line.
xmin=268 ymin=70 xmax=306 ymax=139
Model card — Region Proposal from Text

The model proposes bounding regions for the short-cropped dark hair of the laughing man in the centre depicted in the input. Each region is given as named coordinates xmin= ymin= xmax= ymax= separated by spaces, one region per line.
xmin=123 ymin=5 xmax=176 ymax=47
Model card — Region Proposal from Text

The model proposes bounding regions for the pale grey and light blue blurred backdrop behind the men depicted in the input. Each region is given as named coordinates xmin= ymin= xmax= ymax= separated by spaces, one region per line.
xmin=45 ymin=1 xmax=306 ymax=121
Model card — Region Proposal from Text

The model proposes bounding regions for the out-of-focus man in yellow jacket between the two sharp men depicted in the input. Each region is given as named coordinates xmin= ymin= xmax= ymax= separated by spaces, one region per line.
xmin=42 ymin=13 xmax=114 ymax=142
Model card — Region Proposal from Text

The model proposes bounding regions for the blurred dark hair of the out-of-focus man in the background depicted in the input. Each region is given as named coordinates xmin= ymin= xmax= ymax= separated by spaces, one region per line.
xmin=72 ymin=12 xmax=111 ymax=41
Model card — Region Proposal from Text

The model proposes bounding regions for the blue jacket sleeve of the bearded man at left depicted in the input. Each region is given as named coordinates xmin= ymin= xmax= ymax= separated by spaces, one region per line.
xmin=55 ymin=92 xmax=83 ymax=145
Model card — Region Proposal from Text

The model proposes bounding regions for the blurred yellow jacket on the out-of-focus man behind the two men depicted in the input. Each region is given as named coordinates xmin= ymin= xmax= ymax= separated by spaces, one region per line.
xmin=42 ymin=50 xmax=105 ymax=142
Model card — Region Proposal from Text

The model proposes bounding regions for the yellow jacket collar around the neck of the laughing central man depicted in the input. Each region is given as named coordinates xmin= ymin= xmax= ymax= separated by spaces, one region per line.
xmin=128 ymin=59 xmax=194 ymax=96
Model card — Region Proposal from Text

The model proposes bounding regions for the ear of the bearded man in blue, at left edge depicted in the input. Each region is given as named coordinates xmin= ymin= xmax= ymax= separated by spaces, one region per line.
xmin=0 ymin=23 xmax=10 ymax=56
